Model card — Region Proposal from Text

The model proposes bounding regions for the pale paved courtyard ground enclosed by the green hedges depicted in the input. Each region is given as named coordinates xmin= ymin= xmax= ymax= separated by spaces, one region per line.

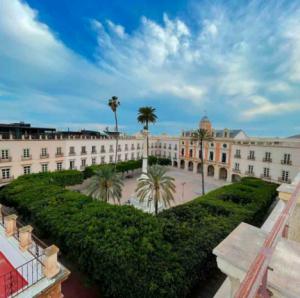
xmin=68 ymin=167 xmax=229 ymax=206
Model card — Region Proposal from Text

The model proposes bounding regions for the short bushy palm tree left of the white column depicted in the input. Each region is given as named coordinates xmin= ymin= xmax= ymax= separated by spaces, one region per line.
xmin=84 ymin=166 xmax=124 ymax=204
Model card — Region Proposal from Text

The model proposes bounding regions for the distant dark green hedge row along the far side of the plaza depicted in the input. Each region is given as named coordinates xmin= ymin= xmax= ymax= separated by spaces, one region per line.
xmin=83 ymin=156 xmax=171 ymax=178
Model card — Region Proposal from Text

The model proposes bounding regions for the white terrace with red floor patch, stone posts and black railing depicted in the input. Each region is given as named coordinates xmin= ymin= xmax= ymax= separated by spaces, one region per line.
xmin=0 ymin=205 xmax=69 ymax=298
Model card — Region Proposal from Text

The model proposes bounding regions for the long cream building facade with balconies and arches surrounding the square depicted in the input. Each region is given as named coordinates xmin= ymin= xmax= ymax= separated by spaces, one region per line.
xmin=0 ymin=117 xmax=300 ymax=185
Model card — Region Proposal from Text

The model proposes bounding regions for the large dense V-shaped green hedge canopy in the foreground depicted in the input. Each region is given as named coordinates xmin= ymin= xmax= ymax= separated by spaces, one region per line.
xmin=0 ymin=172 xmax=276 ymax=298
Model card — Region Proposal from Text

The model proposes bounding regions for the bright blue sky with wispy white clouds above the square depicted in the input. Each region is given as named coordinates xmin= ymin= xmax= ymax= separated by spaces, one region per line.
xmin=0 ymin=0 xmax=300 ymax=136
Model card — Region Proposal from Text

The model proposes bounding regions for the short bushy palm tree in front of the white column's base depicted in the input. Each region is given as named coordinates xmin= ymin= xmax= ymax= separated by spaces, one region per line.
xmin=136 ymin=165 xmax=176 ymax=215
